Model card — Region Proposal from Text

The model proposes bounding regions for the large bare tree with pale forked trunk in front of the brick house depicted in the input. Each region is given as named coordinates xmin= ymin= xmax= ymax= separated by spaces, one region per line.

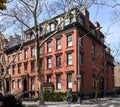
xmin=0 ymin=0 xmax=112 ymax=105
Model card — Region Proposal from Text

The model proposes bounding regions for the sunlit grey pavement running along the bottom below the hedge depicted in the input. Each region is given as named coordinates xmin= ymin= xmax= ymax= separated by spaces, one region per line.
xmin=21 ymin=97 xmax=120 ymax=107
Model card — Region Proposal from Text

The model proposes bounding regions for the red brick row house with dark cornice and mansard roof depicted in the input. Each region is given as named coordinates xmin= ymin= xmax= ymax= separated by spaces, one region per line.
xmin=0 ymin=9 xmax=114 ymax=98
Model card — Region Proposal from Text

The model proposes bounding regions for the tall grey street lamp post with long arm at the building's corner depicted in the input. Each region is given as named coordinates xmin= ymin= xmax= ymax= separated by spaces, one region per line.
xmin=76 ymin=27 xmax=102 ymax=102
